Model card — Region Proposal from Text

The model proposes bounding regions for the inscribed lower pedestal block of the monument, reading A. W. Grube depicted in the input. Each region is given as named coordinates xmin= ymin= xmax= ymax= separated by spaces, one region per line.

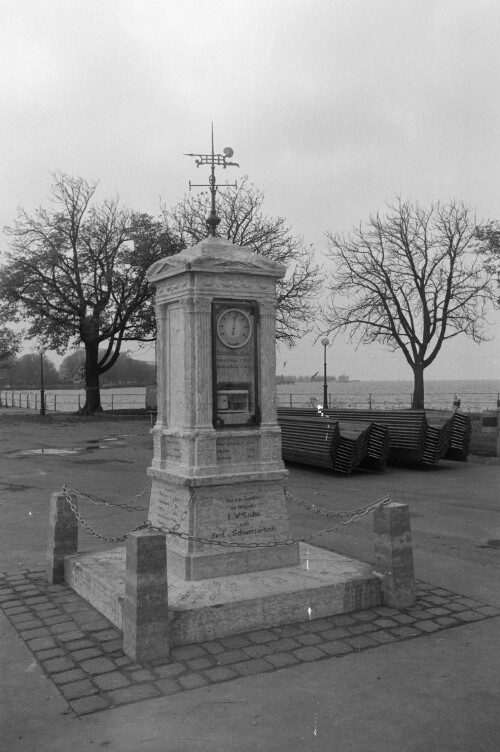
xmin=148 ymin=468 xmax=299 ymax=581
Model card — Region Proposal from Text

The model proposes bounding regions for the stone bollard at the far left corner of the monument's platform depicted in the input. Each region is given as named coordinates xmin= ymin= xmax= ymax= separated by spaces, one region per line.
xmin=46 ymin=492 xmax=78 ymax=584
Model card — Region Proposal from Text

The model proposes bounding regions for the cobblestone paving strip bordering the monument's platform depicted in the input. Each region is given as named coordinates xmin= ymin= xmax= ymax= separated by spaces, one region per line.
xmin=0 ymin=570 xmax=500 ymax=716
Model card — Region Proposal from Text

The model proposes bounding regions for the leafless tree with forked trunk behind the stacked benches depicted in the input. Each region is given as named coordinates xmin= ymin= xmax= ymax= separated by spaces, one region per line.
xmin=324 ymin=199 xmax=493 ymax=409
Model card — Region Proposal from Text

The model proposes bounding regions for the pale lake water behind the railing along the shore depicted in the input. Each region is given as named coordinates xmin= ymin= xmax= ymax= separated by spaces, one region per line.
xmin=0 ymin=379 xmax=500 ymax=412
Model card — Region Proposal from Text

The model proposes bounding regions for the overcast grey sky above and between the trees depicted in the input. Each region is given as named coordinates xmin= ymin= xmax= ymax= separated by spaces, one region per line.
xmin=0 ymin=0 xmax=500 ymax=380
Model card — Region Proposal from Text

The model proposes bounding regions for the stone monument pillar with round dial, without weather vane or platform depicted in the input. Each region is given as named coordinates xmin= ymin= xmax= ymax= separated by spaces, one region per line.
xmin=148 ymin=237 xmax=299 ymax=580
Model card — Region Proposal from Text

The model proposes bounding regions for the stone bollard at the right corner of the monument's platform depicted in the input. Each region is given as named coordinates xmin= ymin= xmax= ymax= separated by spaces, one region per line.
xmin=373 ymin=501 xmax=415 ymax=608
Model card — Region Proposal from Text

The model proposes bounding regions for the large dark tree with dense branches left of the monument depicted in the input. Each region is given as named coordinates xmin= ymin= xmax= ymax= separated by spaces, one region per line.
xmin=0 ymin=173 xmax=177 ymax=413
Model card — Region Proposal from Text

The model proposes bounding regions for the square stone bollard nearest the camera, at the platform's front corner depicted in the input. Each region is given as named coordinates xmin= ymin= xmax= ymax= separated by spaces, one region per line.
xmin=123 ymin=530 xmax=170 ymax=661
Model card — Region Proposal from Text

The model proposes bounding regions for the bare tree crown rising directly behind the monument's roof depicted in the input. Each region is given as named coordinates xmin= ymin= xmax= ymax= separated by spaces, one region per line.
xmin=163 ymin=178 xmax=323 ymax=346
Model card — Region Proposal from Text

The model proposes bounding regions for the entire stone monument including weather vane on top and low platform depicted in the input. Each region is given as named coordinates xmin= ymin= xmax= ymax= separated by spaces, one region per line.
xmin=62 ymin=136 xmax=406 ymax=657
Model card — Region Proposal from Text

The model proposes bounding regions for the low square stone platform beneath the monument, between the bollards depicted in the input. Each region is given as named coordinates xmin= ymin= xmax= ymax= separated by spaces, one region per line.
xmin=65 ymin=543 xmax=382 ymax=646
